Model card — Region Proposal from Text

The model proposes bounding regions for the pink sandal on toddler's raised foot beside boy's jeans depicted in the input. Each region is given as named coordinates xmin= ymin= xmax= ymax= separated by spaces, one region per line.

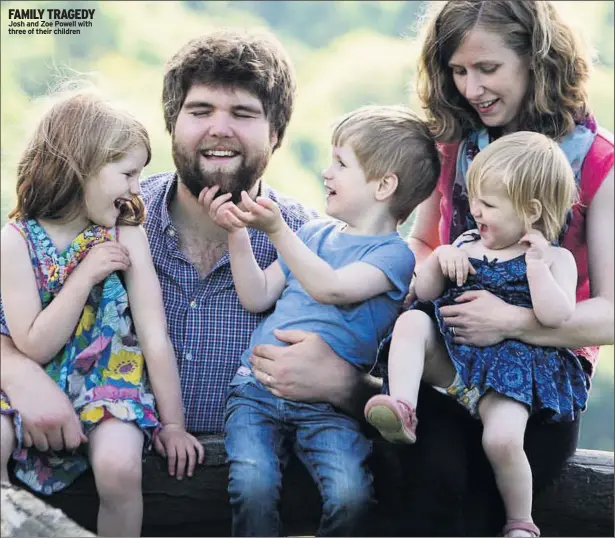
xmin=365 ymin=394 xmax=418 ymax=444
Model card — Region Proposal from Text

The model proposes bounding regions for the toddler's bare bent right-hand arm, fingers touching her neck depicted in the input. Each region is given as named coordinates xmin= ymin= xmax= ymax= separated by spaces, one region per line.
xmin=522 ymin=234 xmax=577 ymax=328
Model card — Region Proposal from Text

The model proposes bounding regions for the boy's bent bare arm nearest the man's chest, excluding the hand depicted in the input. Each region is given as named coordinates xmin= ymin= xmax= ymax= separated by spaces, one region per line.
xmin=228 ymin=228 xmax=286 ymax=313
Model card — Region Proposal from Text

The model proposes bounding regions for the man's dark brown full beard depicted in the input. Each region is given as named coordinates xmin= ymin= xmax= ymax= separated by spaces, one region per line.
xmin=172 ymin=139 xmax=271 ymax=204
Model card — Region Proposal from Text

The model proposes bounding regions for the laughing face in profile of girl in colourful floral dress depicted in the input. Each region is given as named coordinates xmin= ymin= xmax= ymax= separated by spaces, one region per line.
xmin=84 ymin=144 xmax=147 ymax=228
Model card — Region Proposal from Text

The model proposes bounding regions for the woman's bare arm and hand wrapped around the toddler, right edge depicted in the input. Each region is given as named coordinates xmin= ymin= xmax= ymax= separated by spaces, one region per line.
xmin=440 ymin=169 xmax=614 ymax=348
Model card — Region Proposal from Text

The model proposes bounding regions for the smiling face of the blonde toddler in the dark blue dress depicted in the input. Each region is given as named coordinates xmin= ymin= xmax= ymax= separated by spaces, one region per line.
xmin=470 ymin=179 xmax=529 ymax=250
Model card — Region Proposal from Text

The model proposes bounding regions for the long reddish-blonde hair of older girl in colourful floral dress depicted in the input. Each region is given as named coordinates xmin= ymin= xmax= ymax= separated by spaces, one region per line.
xmin=9 ymin=89 xmax=151 ymax=225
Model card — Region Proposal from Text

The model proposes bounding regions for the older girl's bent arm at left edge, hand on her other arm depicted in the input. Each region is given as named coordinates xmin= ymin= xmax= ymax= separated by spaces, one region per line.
xmin=1 ymin=225 xmax=129 ymax=364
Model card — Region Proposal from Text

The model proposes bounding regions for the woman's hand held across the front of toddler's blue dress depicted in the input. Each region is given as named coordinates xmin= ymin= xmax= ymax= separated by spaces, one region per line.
xmin=440 ymin=290 xmax=533 ymax=347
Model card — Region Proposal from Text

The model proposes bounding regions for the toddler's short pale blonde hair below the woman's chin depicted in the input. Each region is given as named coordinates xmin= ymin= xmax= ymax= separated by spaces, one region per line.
xmin=468 ymin=131 xmax=577 ymax=241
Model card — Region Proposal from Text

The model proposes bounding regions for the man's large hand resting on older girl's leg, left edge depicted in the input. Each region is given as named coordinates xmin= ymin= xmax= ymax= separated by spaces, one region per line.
xmin=1 ymin=336 xmax=87 ymax=451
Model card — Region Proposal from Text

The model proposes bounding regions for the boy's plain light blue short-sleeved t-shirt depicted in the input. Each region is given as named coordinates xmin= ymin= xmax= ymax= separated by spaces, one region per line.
xmin=231 ymin=219 xmax=414 ymax=385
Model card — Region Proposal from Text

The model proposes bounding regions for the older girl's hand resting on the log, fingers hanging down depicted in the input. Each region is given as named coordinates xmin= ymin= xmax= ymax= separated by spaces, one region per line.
xmin=154 ymin=424 xmax=205 ymax=480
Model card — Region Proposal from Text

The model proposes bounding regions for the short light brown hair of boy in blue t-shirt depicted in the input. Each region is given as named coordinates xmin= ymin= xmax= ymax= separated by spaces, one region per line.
xmin=331 ymin=105 xmax=440 ymax=222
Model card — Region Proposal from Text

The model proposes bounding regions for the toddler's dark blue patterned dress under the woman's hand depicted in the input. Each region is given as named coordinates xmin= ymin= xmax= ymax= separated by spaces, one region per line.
xmin=411 ymin=249 xmax=590 ymax=422
